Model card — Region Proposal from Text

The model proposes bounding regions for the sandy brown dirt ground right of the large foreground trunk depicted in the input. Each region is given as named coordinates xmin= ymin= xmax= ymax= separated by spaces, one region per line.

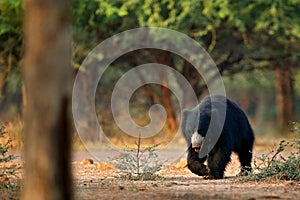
xmin=73 ymin=151 xmax=300 ymax=200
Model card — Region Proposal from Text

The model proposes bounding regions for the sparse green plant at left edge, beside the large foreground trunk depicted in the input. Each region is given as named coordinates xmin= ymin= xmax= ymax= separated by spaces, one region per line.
xmin=0 ymin=125 xmax=19 ymax=189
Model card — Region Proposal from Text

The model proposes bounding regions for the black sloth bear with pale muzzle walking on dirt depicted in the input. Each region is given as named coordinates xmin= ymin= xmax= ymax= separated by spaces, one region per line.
xmin=181 ymin=95 xmax=254 ymax=179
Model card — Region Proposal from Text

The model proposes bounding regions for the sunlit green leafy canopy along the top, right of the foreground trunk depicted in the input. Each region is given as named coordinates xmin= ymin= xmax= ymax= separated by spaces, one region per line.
xmin=68 ymin=0 xmax=300 ymax=73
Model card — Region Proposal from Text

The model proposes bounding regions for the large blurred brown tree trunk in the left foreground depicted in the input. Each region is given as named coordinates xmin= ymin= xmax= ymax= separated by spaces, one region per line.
xmin=22 ymin=0 xmax=72 ymax=200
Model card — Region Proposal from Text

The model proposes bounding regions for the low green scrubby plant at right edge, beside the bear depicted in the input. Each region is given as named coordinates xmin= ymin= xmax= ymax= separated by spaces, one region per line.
xmin=247 ymin=122 xmax=300 ymax=181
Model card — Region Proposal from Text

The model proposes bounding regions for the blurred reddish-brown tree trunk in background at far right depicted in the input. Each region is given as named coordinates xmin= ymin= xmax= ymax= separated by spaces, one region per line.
xmin=275 ymin=67 xmax=293 ymax=131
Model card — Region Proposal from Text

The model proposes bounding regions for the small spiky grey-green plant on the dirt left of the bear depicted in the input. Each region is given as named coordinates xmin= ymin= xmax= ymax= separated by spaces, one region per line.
xmin=113 ymin=135 xmax=163 ymax=180
